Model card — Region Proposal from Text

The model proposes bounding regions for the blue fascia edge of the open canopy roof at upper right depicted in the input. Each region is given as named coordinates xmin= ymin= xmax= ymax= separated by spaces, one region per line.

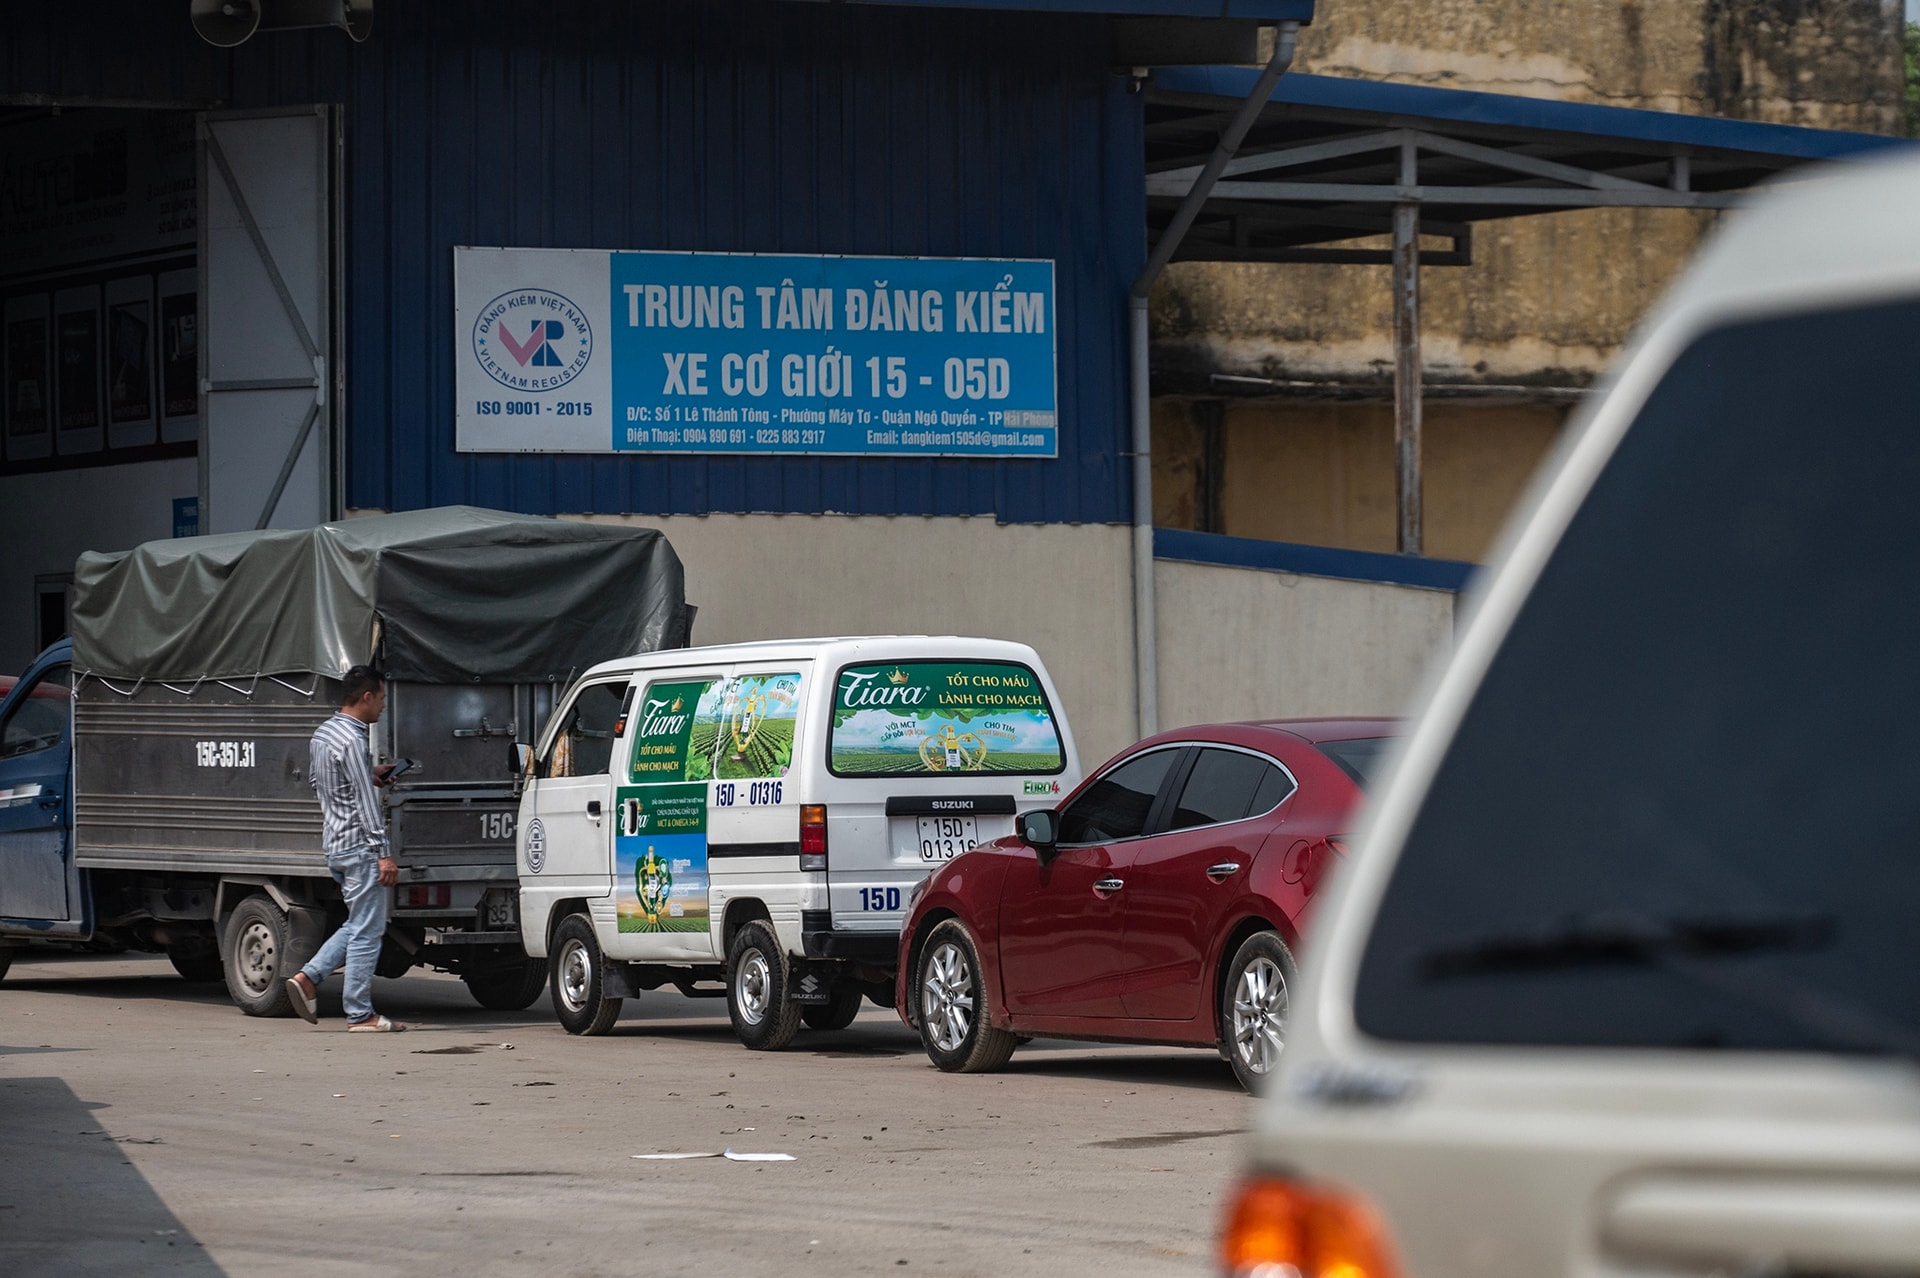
xmin=1152 ymin=67 xmax=1914 ymax=159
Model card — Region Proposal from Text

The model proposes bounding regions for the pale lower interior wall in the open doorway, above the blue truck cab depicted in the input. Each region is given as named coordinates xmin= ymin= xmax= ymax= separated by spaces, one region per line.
xmin=0 ymin=457 xmax=200 ymax=674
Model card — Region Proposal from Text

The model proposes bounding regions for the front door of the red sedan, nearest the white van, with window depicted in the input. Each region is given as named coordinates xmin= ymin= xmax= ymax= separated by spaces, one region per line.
xmin=1000 ymin=746 xmax=1181 ymax=1017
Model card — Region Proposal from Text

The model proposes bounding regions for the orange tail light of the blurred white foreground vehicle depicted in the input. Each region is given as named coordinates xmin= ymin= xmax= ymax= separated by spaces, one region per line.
xmin=1219 ymin=1176 xmax=1400 ymax=1278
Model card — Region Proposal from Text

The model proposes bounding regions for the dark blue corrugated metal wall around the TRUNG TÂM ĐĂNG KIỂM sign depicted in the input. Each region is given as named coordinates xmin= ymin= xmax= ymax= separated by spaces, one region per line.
xmin=0 ymin=0 xmax=1144 ymax=522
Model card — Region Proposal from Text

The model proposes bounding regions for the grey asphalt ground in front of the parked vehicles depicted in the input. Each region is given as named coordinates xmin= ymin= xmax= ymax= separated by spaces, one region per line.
xmin=0 ymin=950 xmax=1252 ymax=1278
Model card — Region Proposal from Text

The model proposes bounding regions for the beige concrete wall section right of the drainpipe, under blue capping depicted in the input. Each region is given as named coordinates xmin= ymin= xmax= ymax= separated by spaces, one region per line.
xmin=1154 ymin=560 xmax=1455 ymax=727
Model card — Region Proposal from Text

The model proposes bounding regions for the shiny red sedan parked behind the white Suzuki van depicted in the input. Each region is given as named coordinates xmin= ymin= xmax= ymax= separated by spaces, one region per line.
xmin=895 ymin=720 xmax=1398 ymax=1090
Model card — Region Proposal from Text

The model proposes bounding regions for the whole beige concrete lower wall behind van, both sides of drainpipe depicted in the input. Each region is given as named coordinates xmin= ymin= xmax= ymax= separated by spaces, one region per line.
xmin=564 ymin=514 xmax=1453 ymax=766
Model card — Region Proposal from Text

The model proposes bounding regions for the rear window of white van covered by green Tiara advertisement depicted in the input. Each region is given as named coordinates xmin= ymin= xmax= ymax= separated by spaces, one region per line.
xmin=828 ymin=660 xmax=1066 ymax=777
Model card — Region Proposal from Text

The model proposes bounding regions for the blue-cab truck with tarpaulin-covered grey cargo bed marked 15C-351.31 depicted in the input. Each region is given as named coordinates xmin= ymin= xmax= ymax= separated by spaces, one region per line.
xmin=0 ymin=507 xmax=691 ymax=1015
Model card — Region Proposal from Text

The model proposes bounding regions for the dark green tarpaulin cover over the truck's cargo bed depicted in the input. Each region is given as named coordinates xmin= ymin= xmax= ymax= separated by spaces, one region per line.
xmin=73 ymin=507 xmax=689 ymax=683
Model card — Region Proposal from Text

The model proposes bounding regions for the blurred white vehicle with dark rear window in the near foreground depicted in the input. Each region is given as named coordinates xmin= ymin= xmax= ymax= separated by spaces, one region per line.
xmin=1223 ymin=159 xmax=1920 ymax=1278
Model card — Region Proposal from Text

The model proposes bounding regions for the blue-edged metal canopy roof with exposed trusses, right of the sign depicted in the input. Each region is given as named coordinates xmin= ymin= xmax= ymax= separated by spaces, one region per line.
xmin=1146 ymin=67 xmax=1912 ymax=265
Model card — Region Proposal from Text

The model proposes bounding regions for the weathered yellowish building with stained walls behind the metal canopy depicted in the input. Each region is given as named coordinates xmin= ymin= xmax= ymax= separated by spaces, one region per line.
xmin=1154 ymin=0 xmax=1903 ymax=560
